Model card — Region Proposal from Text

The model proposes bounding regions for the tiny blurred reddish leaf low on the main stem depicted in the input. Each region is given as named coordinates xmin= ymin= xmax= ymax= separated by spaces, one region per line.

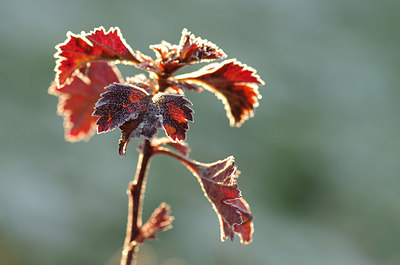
xmin=135 ymin=203 xmax=174 ymax=243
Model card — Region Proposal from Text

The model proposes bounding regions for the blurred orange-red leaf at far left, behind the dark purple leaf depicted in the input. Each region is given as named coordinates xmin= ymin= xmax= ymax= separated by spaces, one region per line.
xmin=49 ymin=62 xmax=122 ymax=142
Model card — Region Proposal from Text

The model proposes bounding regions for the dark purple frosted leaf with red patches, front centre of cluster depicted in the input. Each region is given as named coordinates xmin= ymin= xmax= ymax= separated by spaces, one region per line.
xmin=93 ymin=83 xmax=193 ymax=155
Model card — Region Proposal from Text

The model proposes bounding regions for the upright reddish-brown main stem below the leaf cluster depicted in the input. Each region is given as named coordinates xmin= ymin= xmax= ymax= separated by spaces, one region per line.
xmin=120 ymin=139 xmax=153 ymax=265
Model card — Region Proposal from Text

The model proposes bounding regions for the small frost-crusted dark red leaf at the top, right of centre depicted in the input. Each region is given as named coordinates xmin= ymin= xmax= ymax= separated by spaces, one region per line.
xmin=178 ymin=29 xmax=226 ymax=63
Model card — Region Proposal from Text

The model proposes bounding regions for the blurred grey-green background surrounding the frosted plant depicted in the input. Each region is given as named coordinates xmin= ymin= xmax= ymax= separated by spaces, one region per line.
xmin=0 ymin=0 xmax=400 ymax=265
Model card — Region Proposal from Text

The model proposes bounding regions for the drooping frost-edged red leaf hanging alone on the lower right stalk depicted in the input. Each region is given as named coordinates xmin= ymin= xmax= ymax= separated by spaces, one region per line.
xmin=183 ymin=156 xmax=254 ymax=245
